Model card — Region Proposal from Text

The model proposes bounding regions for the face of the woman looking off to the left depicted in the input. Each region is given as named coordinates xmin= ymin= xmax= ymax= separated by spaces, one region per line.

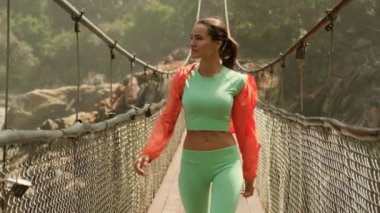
xmin=190 ymin=24 xmax=221 ymax=59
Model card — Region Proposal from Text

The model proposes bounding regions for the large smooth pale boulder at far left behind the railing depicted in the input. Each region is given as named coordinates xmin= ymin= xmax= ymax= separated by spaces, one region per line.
xmin=8 ymin=84 xmax=110 ymax=130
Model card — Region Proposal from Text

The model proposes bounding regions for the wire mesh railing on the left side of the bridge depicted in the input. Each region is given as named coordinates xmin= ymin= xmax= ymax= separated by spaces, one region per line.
xmin=0 ymin=106 xmax=184 ymax=213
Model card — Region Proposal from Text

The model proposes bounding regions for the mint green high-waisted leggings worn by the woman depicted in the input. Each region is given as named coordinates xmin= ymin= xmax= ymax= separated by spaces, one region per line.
xmin=178 ymin=145 xmax=243 ymax=213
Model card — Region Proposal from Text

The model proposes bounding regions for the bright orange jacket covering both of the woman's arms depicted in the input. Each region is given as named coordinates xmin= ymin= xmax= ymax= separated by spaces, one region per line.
xmin=141 ymin=64 xmax=261 ymax=181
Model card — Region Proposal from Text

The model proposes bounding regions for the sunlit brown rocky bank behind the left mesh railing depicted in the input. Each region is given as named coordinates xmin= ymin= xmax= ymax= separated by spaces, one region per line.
xmin=2 ymin=65 xmax=171 ymax=130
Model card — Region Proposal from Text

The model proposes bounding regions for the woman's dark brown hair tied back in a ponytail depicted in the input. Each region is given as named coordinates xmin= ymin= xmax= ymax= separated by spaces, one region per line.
xmin=196 ymin=18 xmax=239 ymax=69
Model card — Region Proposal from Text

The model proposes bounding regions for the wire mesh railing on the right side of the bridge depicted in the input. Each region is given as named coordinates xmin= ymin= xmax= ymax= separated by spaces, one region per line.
xmin=256 ymin=106 xmax=380 ymax=212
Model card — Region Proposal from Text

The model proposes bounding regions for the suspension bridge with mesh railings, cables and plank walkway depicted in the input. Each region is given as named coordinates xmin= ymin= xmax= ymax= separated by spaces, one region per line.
xmin=0 ymin=0 xmax=380 ymax=213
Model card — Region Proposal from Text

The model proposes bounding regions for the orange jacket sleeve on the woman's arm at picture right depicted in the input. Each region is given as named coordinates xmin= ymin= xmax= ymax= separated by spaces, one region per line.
xmin=231 ymin=75 xmax=261 ymax=182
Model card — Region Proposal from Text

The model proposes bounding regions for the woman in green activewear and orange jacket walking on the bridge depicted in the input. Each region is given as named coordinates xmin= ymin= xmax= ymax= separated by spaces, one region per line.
xmin=135 ymin=18 xmax=260 ymax=213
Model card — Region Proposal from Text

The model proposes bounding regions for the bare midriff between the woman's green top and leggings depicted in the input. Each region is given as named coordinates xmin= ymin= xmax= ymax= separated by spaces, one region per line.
xmin=183 ymin=130 xmax=236 ymax=151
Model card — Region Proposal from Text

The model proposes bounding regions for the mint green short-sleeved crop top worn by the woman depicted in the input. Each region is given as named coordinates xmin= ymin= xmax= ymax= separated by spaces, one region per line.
xmin=182 ymin=67 xmax=246 ymax=131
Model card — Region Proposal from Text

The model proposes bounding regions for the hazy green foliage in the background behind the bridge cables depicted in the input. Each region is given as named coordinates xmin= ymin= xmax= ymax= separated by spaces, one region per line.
xmin=0 ymin=0 xmax=380 ymax=98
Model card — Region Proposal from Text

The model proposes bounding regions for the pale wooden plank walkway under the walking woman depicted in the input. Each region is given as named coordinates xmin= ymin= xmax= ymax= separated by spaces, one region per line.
xmin=148 ymin=134 xmax=265 ymax=213
